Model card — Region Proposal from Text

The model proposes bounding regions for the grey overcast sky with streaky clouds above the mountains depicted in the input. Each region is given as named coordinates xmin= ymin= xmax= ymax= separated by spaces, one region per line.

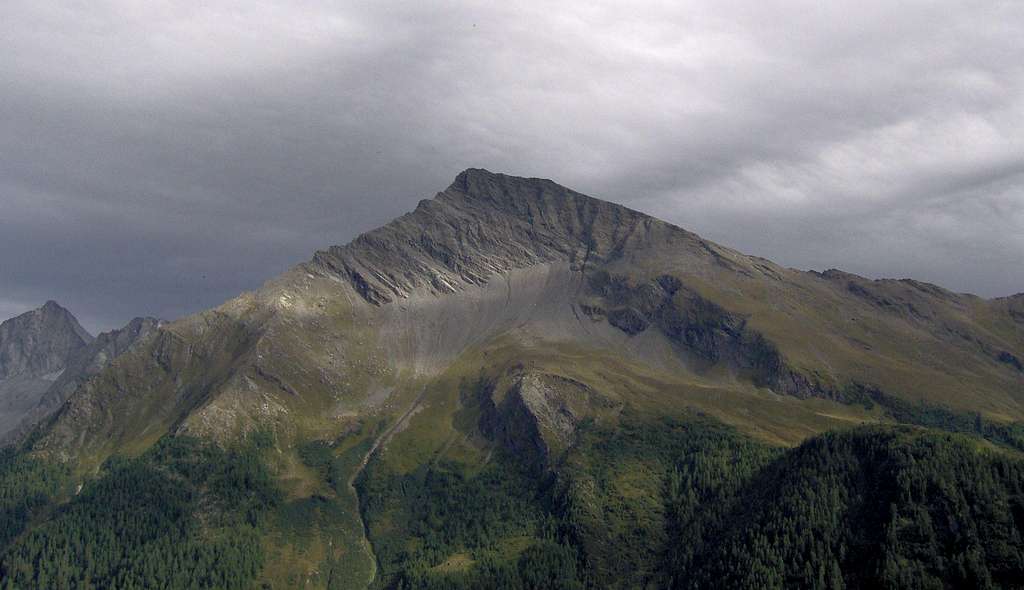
xmin=0 ymin=0 xmax=1024 ymax=332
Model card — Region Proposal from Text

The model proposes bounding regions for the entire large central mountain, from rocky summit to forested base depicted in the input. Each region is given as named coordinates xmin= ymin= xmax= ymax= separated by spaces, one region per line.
xmin=0 ymin=170 xmax=1024 ymax=588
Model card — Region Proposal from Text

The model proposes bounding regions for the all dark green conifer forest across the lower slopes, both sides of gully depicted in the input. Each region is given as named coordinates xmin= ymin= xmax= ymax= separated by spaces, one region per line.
xmin=0 ymin=416 xmax=1024 ymax=590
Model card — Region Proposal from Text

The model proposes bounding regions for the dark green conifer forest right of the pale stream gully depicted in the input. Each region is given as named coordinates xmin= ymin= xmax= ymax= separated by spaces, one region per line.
xmin=354 ymin=419 xmax=1024 ymax=589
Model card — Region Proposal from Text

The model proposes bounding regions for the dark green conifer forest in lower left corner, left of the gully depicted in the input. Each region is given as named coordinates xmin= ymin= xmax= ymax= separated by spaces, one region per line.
xmin=0 ymin=436 xmax=280 ymax=589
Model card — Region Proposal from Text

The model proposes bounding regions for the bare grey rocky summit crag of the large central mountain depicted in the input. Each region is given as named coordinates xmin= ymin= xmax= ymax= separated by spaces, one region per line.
xmin=307 ymin=168 xmax=699 ymax=305
